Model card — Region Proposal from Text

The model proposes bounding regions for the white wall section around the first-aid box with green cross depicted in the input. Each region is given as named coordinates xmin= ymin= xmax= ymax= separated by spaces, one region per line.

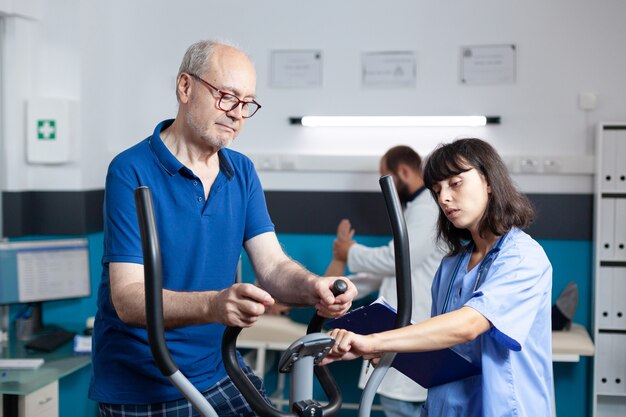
xmin=0 ymin=0 xmax=85 ymax=191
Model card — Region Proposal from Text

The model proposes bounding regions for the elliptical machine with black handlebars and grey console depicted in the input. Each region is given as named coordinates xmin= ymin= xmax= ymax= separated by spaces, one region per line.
xmin=135 ymin=176 xmax=411 ymax=417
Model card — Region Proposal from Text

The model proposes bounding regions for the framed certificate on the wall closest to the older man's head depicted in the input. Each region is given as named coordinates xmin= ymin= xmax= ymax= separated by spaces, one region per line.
xmin=270 ymin=51 xmax=322 ymax=88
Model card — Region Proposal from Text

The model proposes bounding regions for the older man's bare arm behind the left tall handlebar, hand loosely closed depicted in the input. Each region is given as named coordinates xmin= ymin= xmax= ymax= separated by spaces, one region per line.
xmin=109 ymin=262 xmax=274 ymax=329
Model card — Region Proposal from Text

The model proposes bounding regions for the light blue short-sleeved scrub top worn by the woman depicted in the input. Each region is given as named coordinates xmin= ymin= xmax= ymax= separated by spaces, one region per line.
xmin=422 ymin=228 xmax=553 ymax=417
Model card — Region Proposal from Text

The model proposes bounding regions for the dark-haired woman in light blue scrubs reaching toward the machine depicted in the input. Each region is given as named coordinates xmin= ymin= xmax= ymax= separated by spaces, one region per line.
xmin=325 ymin=139 xmax=552 ymax=417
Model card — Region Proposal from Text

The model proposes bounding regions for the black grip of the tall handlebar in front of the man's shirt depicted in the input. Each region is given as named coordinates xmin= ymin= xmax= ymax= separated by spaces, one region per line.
xmin=135 ymin=187 xmax=178 ymax=377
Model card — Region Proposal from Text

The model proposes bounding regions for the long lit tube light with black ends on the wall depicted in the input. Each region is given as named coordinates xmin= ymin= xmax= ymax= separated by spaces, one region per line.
xmin=289 ymin=116 xmax=500 ymax=127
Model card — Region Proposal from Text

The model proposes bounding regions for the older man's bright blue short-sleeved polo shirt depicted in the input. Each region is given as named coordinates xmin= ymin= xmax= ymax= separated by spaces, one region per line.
xmin=89 ymin=120 xmax=274 ymax=404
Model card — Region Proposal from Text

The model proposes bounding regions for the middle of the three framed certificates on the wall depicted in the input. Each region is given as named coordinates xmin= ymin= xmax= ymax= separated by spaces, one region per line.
xmin=362 ymin=51 xmax=417 ymax=88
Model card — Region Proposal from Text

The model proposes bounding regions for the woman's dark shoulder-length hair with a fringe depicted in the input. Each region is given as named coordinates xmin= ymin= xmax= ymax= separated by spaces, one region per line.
xmin=424 ymin=138 xmax=535 ymax=254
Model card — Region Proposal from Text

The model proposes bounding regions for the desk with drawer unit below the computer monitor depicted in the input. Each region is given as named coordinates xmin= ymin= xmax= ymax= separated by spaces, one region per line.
xmin=0 ymin=334 xmax=91 ymax=417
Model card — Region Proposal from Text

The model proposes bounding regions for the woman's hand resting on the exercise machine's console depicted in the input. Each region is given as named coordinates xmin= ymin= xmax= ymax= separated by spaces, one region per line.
xmin=321 ymin=329 xmax=381 ymax=365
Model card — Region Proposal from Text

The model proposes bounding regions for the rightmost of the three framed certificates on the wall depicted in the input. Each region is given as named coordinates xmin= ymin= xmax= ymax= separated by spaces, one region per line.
xmin=461 ymin=45 xmax=517 ymax=84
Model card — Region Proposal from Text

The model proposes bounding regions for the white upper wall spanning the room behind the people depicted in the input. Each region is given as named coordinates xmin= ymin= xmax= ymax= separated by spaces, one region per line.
xmin=2 ymin=0 xmax=626 ymax=192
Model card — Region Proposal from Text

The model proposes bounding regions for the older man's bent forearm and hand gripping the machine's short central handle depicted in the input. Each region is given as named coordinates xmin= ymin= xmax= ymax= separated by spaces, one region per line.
xmin=244 ymin=232 xmax=357 ymax=317
